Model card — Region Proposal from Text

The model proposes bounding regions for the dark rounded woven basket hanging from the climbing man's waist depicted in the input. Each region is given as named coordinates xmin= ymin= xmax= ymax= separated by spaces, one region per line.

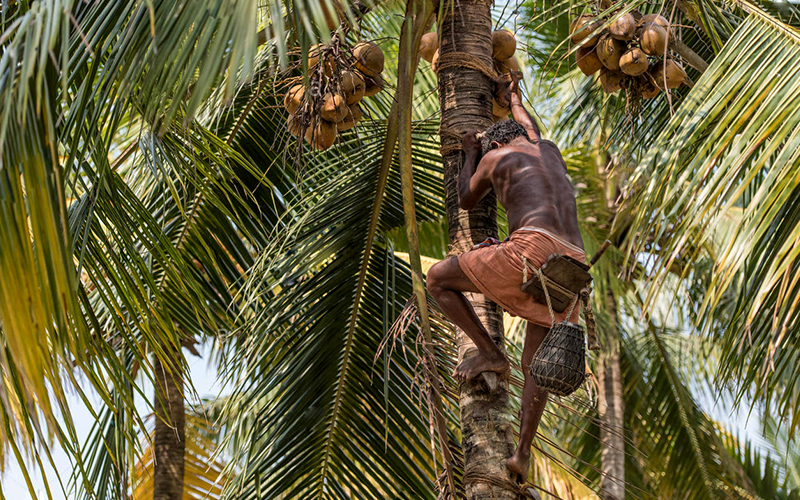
xmin=529 ymin=321 xmax=586 ymax=396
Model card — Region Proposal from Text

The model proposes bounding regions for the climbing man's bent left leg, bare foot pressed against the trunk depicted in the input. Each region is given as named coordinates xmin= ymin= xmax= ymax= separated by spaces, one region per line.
xmin=427 ymin=257 xmax=508 ymax=381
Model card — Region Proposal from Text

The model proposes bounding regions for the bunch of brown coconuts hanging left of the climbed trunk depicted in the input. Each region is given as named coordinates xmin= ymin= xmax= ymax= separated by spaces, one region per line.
xmin=283 ymin=42 xmax=384 ymax=150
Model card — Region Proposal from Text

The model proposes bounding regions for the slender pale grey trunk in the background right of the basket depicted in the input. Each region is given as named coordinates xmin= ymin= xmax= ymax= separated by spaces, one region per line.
xmin=598 ymin=290 xmax=625 ymax=500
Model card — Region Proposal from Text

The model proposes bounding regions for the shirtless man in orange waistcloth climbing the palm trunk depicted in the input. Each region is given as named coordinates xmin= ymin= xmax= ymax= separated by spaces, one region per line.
xmin=427 ymin=78 xmax=586 ymax=482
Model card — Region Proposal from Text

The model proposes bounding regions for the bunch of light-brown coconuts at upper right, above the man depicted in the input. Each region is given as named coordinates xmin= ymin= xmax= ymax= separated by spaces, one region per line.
xmin=570 ymin=10 xmax=686 ymax=99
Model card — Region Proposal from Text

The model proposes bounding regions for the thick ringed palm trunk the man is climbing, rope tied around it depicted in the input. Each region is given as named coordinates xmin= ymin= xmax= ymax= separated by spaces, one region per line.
xmin=439 ymin=0 xmax=516 ymax=500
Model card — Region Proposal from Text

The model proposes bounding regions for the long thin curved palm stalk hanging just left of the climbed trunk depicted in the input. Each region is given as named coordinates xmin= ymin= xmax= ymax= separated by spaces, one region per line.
xmin=395 ymin=0 xmax=456 ymax=496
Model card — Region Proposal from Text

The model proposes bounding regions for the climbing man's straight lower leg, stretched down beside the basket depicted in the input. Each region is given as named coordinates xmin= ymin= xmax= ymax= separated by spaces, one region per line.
xmin=506 ymin=322 xmax=549 ymax=482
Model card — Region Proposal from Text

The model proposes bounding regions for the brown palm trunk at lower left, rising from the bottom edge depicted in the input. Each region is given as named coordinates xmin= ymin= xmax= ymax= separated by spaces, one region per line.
xmin=153 ymin=348 xmax=186 ymax=500
